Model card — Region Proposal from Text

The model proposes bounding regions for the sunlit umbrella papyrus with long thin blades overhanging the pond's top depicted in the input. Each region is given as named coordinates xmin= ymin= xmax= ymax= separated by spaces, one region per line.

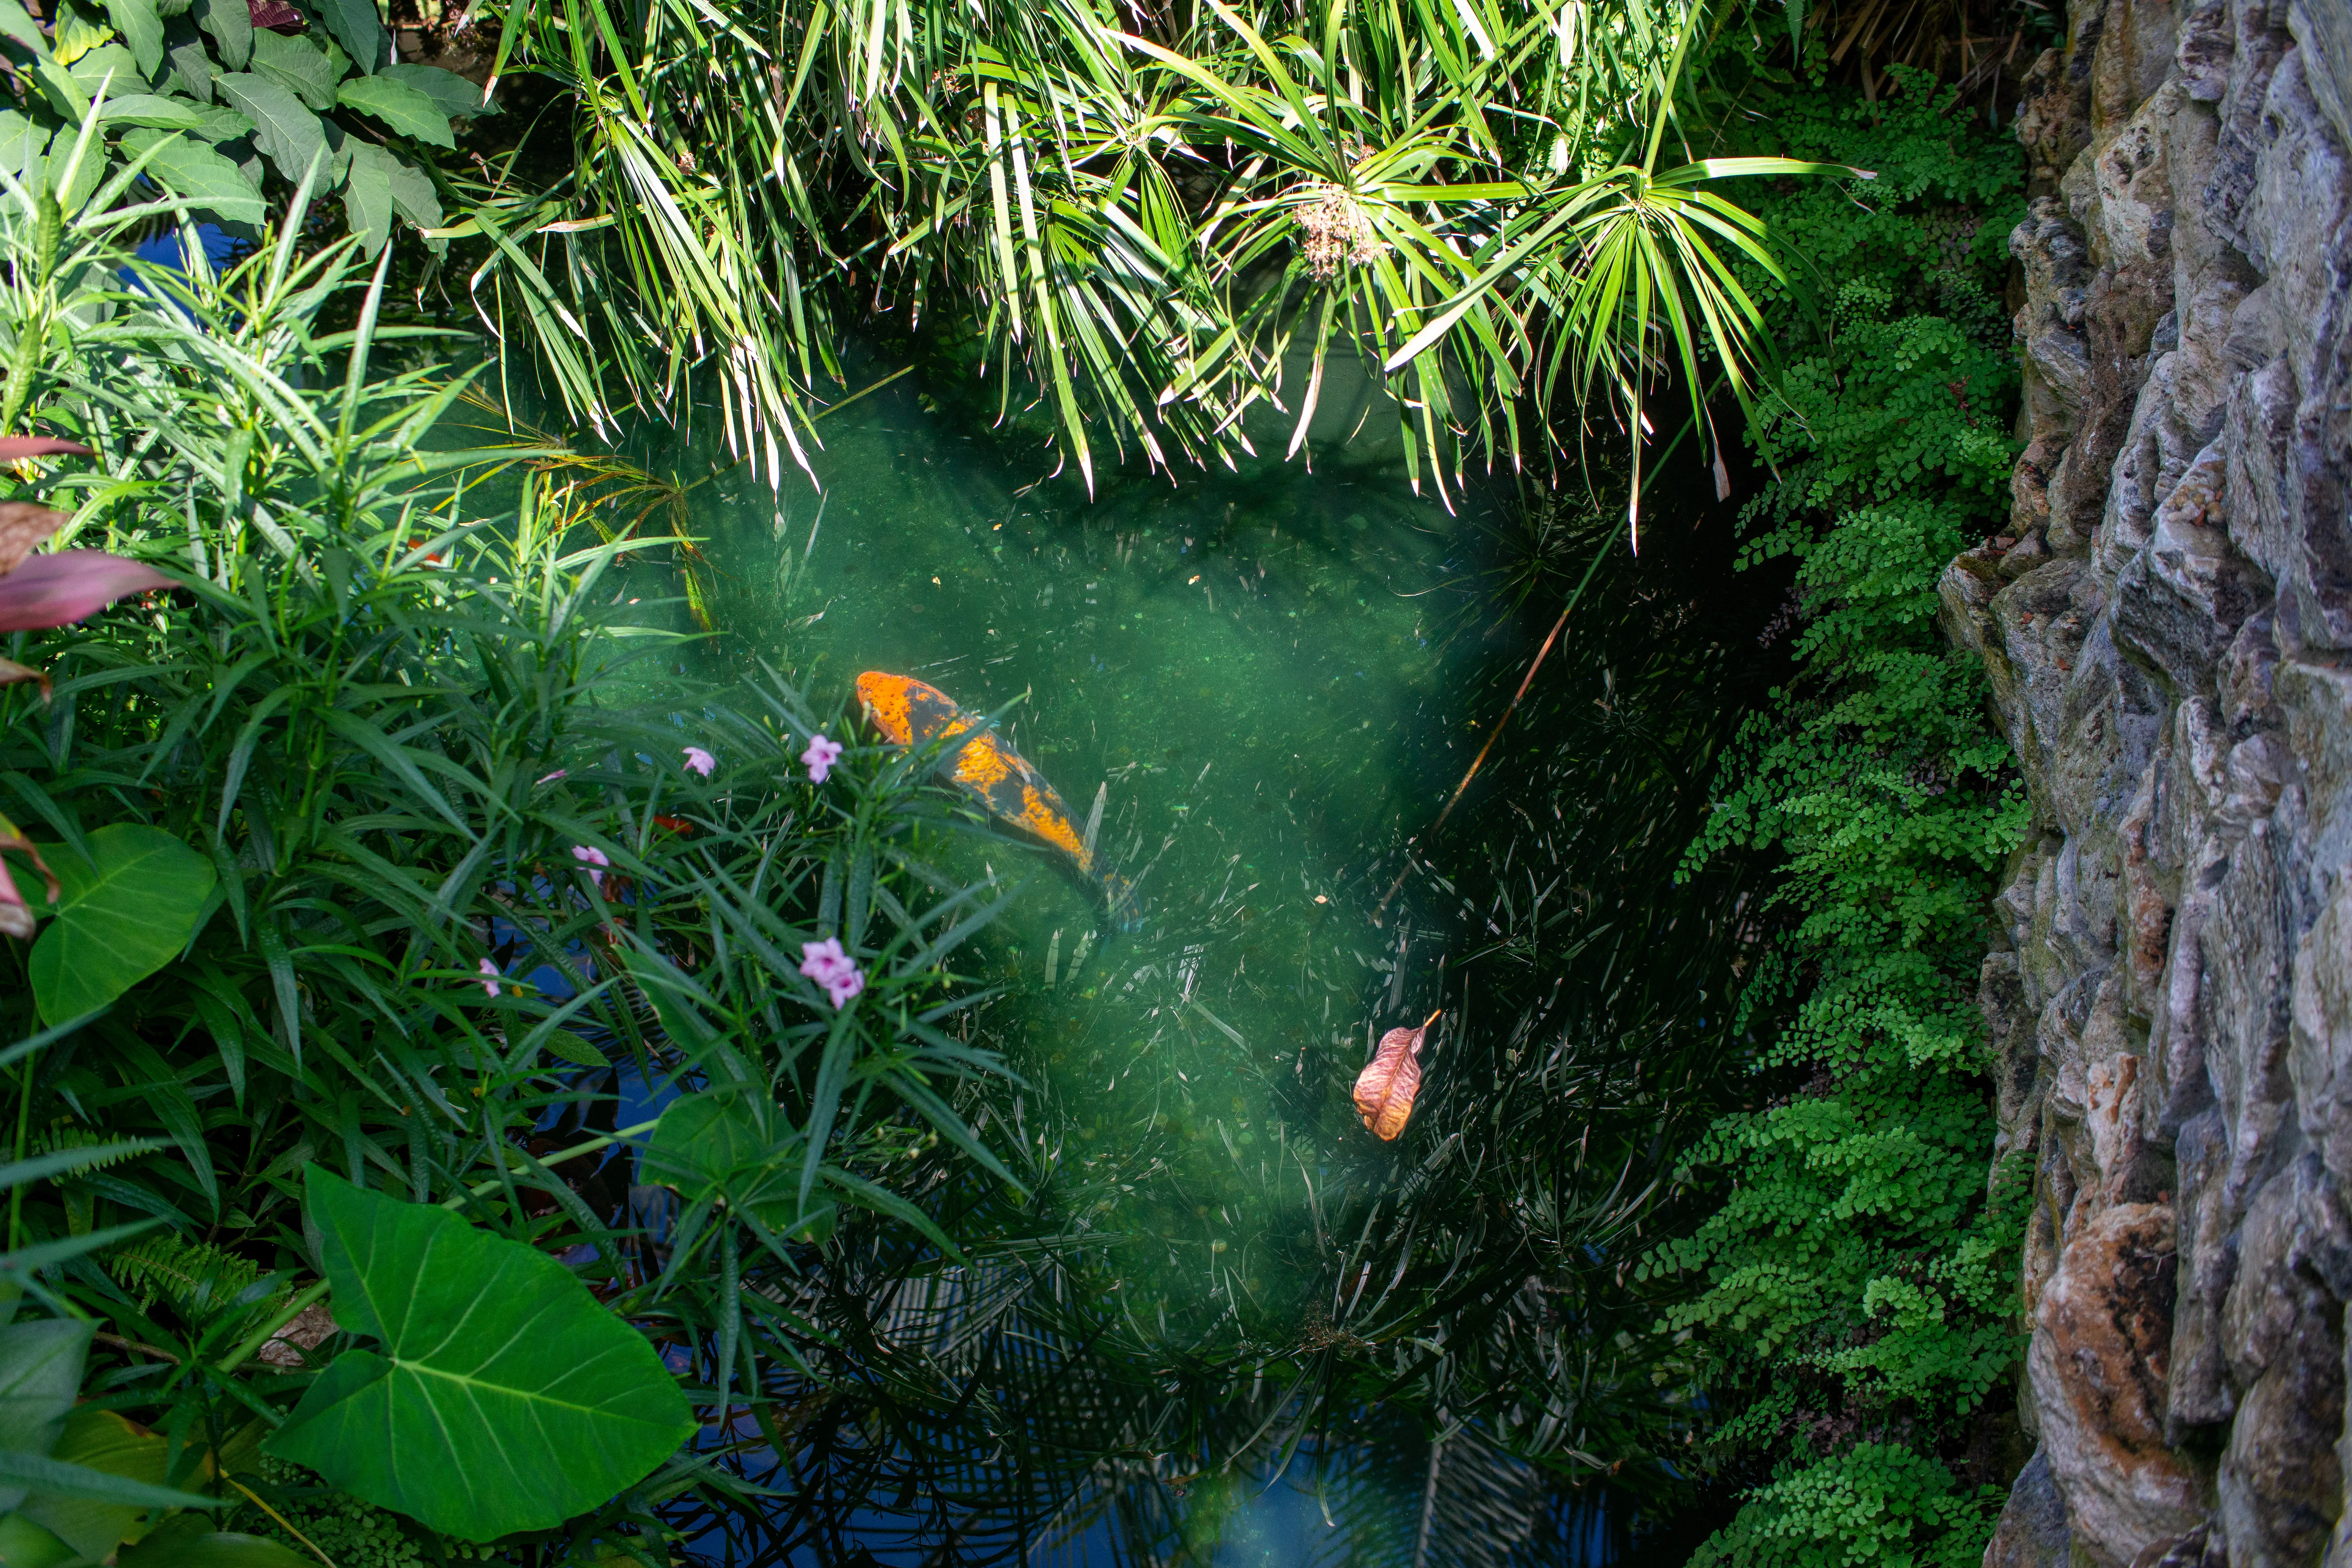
xmin=473 ymin=0 xmax=1837 ymax=522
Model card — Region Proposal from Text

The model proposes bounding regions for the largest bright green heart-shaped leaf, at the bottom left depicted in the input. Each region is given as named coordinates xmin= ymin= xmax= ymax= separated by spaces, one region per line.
xmin=266 ymin=1166 xmax=694 ymax=1540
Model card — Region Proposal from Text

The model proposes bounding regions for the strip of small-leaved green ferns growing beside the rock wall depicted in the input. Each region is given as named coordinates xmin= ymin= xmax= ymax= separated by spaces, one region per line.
xmin=1644 ymin=73 xmax=2027 ymax=1563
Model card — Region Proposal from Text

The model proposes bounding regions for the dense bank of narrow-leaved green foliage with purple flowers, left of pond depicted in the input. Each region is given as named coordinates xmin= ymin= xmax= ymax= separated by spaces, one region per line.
xmin=0 ymin=150 xmax=1030 ymax=1568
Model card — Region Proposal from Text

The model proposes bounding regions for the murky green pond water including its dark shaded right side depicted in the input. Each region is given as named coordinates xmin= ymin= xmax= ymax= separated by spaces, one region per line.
xmin=616 ymin=350 xmax=1778 ymax=1568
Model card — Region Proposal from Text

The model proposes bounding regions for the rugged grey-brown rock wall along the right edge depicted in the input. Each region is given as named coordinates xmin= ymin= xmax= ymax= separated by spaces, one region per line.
xmin=1943 ymin=0 xmax=2352 ymax=1568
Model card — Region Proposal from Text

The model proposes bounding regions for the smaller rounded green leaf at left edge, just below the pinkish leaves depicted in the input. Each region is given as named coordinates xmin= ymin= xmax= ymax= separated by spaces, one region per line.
xmin=26 ymin=823 xmax=219 ymax=1023
